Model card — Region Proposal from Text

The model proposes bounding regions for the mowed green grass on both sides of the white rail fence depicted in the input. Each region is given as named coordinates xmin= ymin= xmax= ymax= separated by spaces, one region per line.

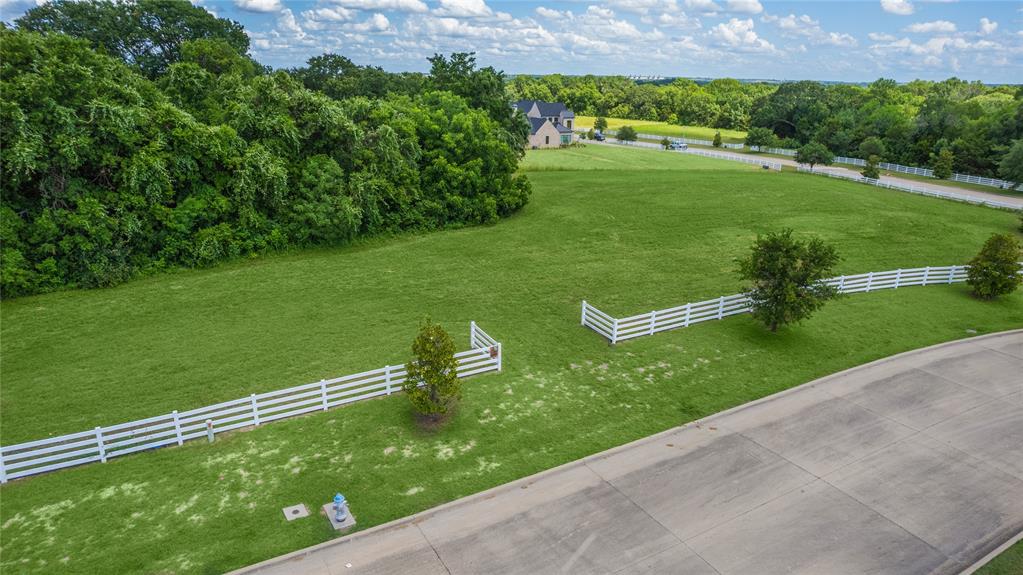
xmin=0 ymin=146 xmax=1023 ymax=573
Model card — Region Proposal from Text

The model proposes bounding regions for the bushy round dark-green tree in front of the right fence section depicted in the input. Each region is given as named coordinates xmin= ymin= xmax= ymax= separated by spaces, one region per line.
xmin=739 ymin=229 xmax=839 ymax=331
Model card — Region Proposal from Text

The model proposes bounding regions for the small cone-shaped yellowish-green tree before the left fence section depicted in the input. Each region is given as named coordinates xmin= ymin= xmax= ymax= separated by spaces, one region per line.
xmin=402 ymin=319 xmax=461 ymax=423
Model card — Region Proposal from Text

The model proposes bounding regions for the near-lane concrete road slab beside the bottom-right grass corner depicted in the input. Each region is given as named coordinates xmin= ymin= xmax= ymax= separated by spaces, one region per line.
xmin=825 ymin=435 xmax=1023 ymax=572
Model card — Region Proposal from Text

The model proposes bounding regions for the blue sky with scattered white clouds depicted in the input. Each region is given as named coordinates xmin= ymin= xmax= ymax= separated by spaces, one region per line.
xmin=0 ymin=0 xmax=1023 ymax=83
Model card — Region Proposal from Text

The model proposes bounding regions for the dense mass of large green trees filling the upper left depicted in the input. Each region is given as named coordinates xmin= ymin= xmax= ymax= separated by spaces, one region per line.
xmin=0 ymin=0 xmax=530 ymax=297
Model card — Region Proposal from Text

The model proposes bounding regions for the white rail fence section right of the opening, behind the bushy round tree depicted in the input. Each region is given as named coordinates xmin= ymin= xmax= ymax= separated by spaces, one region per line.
xmin=582 ymin=262 xmax=1023 ymax=344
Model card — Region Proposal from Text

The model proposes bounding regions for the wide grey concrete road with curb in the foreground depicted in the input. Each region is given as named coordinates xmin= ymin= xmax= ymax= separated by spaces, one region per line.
xmin=236 ymin=330 xmax=1023 ymax=575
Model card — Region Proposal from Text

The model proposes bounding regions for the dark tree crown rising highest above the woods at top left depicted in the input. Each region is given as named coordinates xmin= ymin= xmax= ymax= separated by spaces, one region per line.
xmin=15 ymin=0 xmax=249 ymax=78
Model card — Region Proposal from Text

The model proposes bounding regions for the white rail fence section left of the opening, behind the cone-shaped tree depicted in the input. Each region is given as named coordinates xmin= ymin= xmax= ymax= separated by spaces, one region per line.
xmin=0 ymin=321 xmax=503 ymax=483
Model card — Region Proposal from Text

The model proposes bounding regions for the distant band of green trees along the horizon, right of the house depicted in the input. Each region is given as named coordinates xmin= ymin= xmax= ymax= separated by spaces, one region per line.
xmin=508 ymin=75 xmax=1023 ymax=177
